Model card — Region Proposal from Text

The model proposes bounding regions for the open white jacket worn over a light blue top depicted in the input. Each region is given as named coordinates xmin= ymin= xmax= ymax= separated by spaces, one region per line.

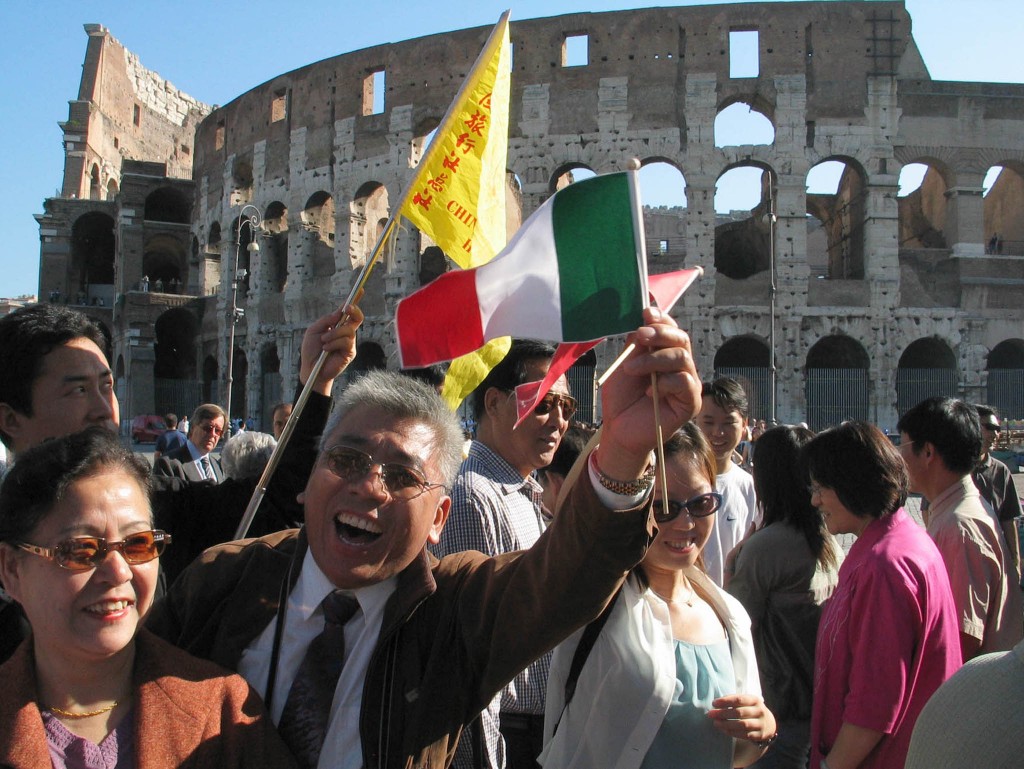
xmin=538 ymin=568 xmax=761 ymax=769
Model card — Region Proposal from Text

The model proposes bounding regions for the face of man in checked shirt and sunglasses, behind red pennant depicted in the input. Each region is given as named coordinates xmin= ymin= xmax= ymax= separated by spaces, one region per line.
xmin=479 ymin=358 xmax=569 ymax=478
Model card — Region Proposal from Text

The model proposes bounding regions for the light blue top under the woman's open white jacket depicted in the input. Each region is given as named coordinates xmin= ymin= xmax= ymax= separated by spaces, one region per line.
xmin=641 ymin=640 xmax=736 ymax=769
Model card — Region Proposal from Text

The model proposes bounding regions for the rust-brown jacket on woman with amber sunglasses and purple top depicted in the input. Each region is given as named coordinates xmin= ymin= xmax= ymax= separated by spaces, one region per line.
xmin=0 ymin=630 xmax=295 ymax=769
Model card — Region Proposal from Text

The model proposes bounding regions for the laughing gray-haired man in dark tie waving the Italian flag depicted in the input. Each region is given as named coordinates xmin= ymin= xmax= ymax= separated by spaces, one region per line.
xmin=150 ymin=309 xmax=700 ymax=769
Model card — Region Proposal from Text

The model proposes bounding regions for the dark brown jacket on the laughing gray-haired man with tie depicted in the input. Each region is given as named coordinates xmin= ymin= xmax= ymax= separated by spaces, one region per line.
xmin=148 ymin=462 xmax=649 ymax=769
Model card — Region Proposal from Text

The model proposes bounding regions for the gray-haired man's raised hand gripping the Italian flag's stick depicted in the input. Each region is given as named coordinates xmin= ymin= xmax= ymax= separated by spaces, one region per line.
xmin=597 ymin=307 xmax=700 ymax=480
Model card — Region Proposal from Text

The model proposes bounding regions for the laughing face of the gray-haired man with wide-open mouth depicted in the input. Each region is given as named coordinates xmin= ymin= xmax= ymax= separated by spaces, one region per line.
xmin=302 ymin=409 xmax=452 ymax=589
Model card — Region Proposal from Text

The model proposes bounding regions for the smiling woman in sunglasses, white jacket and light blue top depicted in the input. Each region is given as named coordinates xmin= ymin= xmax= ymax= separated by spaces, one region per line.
xmin=540 ymin=423 xmax=775 ymax=769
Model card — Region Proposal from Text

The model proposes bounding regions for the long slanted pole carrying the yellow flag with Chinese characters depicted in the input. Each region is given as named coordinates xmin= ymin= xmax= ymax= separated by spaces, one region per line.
xmin=234 ymin=10 xmax=511 ymax=540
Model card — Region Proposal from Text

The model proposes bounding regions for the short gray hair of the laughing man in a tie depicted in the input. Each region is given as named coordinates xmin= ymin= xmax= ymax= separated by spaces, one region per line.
xmin=321 ymin=370 xmax=463 ymax=486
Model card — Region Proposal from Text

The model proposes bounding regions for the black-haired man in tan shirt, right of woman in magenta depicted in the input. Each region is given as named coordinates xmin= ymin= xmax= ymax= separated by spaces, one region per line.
xmin=896 ymin=396 xmax=1024 ymax=661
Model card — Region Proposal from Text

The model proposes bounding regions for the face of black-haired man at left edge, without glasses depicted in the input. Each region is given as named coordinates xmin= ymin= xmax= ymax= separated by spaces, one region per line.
xmin=0 ymin=337 xmax=120 ymax=452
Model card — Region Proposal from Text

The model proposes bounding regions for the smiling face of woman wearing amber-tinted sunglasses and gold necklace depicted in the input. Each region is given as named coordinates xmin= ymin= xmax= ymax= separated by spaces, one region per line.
xmin=0 ymin=469 xmax=159 ymax=663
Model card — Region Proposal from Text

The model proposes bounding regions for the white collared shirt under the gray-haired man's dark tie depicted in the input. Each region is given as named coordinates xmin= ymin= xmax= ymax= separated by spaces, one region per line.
xmin=239 ymin=551 xmax=396 ymax=769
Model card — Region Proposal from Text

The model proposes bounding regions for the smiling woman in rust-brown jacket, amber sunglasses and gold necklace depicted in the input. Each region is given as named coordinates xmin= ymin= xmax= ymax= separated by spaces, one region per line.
xmin=0 ymin=428 xmax=294 ymax=769
